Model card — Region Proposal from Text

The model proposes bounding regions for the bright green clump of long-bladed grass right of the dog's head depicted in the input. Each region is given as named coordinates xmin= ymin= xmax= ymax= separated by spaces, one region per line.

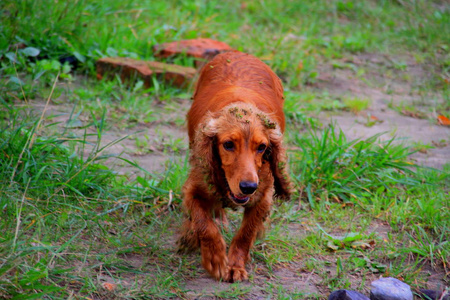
xmin=293 ymin=125 xmax=418 ymax=207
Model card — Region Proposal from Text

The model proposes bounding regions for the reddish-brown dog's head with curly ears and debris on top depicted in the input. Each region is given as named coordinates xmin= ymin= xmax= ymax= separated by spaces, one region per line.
xmin=192 ymin=103 xmax=290 ymax=205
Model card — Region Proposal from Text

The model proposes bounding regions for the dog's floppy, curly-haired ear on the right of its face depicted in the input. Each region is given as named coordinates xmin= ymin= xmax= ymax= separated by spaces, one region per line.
xmin=264 ymin=127 xmax=292 ymax=199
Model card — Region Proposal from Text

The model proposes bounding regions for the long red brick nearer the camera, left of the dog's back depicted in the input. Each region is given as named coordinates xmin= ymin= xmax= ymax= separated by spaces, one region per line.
xmin=97 ymin=57 xmax=197 ymax=87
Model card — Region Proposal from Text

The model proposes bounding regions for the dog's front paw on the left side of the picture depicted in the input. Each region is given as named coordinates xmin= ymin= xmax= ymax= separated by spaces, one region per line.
xmin=201 ymin=240 xmax=229 ymax=281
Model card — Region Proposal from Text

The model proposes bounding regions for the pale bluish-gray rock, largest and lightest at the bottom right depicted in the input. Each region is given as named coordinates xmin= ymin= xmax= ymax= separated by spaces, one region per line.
xmin=370 ymin=277 xmax=413 ymax=300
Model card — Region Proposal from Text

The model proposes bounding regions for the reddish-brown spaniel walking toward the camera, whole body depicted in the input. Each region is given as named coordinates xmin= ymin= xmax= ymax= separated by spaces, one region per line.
xmin=178 ymin=51 xmax=290 ymax=282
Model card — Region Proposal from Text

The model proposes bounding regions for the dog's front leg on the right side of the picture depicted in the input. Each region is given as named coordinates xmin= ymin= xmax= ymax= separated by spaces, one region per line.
xmin=227 ymin=197 xmax=271 ymax=282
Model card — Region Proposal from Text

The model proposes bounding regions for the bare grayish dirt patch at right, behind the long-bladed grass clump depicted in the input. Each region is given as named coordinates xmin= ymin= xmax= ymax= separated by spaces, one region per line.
xmin=316 ymin=54 xmax=450 ymax=169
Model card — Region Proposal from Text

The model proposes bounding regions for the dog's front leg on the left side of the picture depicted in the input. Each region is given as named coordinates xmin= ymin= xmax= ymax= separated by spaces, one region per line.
xmin=188 ymin=198 xmax=229 ymax=281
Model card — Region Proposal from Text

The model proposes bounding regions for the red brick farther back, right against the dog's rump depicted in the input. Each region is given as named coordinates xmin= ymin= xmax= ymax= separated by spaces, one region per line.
xmin=153 ymin=38 xmax=233 ymax=67
